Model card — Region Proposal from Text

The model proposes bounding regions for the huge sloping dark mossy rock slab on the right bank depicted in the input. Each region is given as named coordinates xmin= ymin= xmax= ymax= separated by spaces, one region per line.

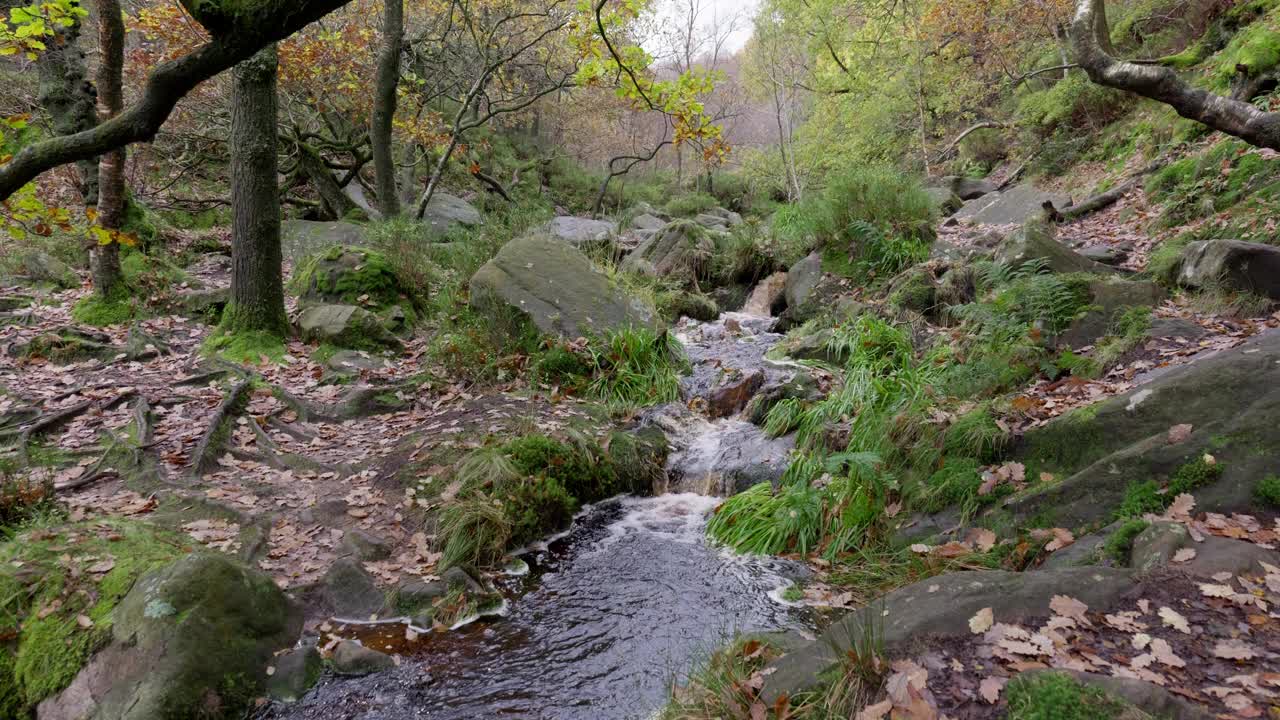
xmin=1006 ymin=332 xmax=1280 ymax=528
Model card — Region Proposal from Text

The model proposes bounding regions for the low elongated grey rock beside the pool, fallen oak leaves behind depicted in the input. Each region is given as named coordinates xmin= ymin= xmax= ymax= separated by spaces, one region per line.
xmin=763 ymin=568 xmax=1133 ymax=705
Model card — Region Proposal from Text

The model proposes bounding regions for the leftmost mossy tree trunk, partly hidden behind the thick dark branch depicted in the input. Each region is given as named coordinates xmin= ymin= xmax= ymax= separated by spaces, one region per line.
xmin=36 ymin=15 xmax=97 ymax=208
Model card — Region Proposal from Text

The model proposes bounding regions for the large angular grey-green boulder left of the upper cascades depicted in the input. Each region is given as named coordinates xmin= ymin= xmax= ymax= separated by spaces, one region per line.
xmin=471 ymin=234 xmax=657 ymax=338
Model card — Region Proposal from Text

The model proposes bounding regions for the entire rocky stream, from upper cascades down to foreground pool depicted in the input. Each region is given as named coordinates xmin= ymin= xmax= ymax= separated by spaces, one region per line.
xmin=269 ymin=285 xmax=815 ymax=720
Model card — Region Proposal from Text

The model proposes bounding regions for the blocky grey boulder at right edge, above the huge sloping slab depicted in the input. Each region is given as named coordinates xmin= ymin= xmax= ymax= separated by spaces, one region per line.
xmin=1178 ymin=240 xmax=1280 ymax=300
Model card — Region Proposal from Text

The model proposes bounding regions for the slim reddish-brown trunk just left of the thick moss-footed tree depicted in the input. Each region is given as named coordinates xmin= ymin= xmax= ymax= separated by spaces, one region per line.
xmin=88 ymin=0 xmax=125 ymax=299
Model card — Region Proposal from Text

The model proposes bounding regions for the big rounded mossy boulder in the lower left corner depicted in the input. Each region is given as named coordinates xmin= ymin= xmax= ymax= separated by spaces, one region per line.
xmin=38 ymin=552 xmax=302 ymax=720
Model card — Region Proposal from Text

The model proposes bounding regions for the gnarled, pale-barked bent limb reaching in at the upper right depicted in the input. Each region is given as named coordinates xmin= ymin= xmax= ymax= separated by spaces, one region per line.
xmin=1071 ymin=0 xmax=1280 ymax=150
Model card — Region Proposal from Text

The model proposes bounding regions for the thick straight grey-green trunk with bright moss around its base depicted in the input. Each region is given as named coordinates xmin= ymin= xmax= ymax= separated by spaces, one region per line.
xmin=229 ymin=45 xmax=289 ymax=337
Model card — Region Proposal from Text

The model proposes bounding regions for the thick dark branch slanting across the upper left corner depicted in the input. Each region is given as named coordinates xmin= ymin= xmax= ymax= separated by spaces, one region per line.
xmin=0 ymin=0 xmax=349 ymax=200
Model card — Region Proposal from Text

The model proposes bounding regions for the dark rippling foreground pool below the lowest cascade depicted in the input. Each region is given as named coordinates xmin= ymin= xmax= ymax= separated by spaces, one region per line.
xmin=273 ymin=495 xmax=809 ymax=720
